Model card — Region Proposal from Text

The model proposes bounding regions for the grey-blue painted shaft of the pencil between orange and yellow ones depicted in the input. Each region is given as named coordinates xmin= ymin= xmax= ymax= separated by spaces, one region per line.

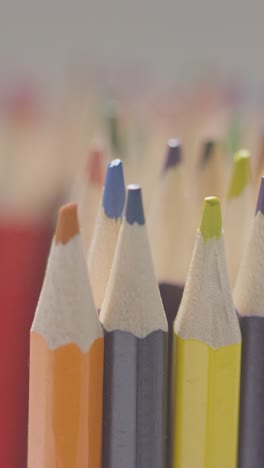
xmin=103 ymin=331 xmax=167 ymax=468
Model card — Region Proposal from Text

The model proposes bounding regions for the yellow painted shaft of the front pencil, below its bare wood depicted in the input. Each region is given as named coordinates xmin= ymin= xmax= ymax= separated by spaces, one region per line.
xmin=173 ymin=334 xmax=241 ymax=468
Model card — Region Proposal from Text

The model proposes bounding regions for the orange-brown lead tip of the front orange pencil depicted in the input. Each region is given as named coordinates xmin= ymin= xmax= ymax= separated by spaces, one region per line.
xmin=55 ymin=203 xmax=80 ymax=244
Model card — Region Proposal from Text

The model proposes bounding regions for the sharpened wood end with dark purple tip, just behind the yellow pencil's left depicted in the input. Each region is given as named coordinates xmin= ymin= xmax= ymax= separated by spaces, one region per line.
xmin=147 ymin=139 xmax=189 ymax=286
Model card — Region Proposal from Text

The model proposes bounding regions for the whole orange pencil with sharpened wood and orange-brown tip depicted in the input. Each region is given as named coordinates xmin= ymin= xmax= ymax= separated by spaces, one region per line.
xmin=28 ymin=204 xmax=104 ymax=468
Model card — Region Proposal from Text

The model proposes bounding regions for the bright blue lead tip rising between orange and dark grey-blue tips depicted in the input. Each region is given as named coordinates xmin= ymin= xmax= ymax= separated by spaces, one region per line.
xmin=103 ymin=159 xmax=126 ymax=219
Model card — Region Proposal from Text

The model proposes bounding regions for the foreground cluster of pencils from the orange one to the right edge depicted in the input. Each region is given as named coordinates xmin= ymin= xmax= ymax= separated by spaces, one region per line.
xmin=28 ymin=136 xmax=264 ymax=468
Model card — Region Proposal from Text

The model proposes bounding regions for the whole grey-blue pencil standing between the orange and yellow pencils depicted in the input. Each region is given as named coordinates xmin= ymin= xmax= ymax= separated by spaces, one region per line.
xmin=100 ymin=185 xmax=168 ymax=468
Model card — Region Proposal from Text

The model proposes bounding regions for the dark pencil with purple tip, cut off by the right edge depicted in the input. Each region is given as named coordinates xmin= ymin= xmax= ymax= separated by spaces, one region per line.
xmin=234 ymin=178 xmax=264 ymax=468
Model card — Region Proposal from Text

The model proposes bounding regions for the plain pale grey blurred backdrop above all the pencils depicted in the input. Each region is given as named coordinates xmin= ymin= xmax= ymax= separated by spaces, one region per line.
xmin=0 ymin=0 xmax=264 ymax=97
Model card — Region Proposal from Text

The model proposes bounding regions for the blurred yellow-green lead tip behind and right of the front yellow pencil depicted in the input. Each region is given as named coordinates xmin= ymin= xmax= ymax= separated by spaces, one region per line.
xmin=227 ymin=150 xmax=251 ymax=199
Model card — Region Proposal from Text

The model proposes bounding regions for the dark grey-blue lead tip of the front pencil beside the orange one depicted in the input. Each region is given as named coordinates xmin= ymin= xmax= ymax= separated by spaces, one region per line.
xmin=126 ymin=185 xmax=145 ymax=224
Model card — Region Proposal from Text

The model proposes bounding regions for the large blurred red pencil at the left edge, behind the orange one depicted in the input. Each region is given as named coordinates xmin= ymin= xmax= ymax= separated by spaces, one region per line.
xmin=0 ymin=87 xmax=57 ymax=468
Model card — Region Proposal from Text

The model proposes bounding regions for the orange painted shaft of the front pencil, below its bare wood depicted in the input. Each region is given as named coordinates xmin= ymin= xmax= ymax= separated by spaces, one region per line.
xmin=28 ymin=332 xmax=104 ymax=468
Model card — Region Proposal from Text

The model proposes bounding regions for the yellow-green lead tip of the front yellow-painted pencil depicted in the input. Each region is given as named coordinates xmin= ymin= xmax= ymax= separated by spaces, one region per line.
xmin=200 ymin=197 xmax=222 ymax=240
